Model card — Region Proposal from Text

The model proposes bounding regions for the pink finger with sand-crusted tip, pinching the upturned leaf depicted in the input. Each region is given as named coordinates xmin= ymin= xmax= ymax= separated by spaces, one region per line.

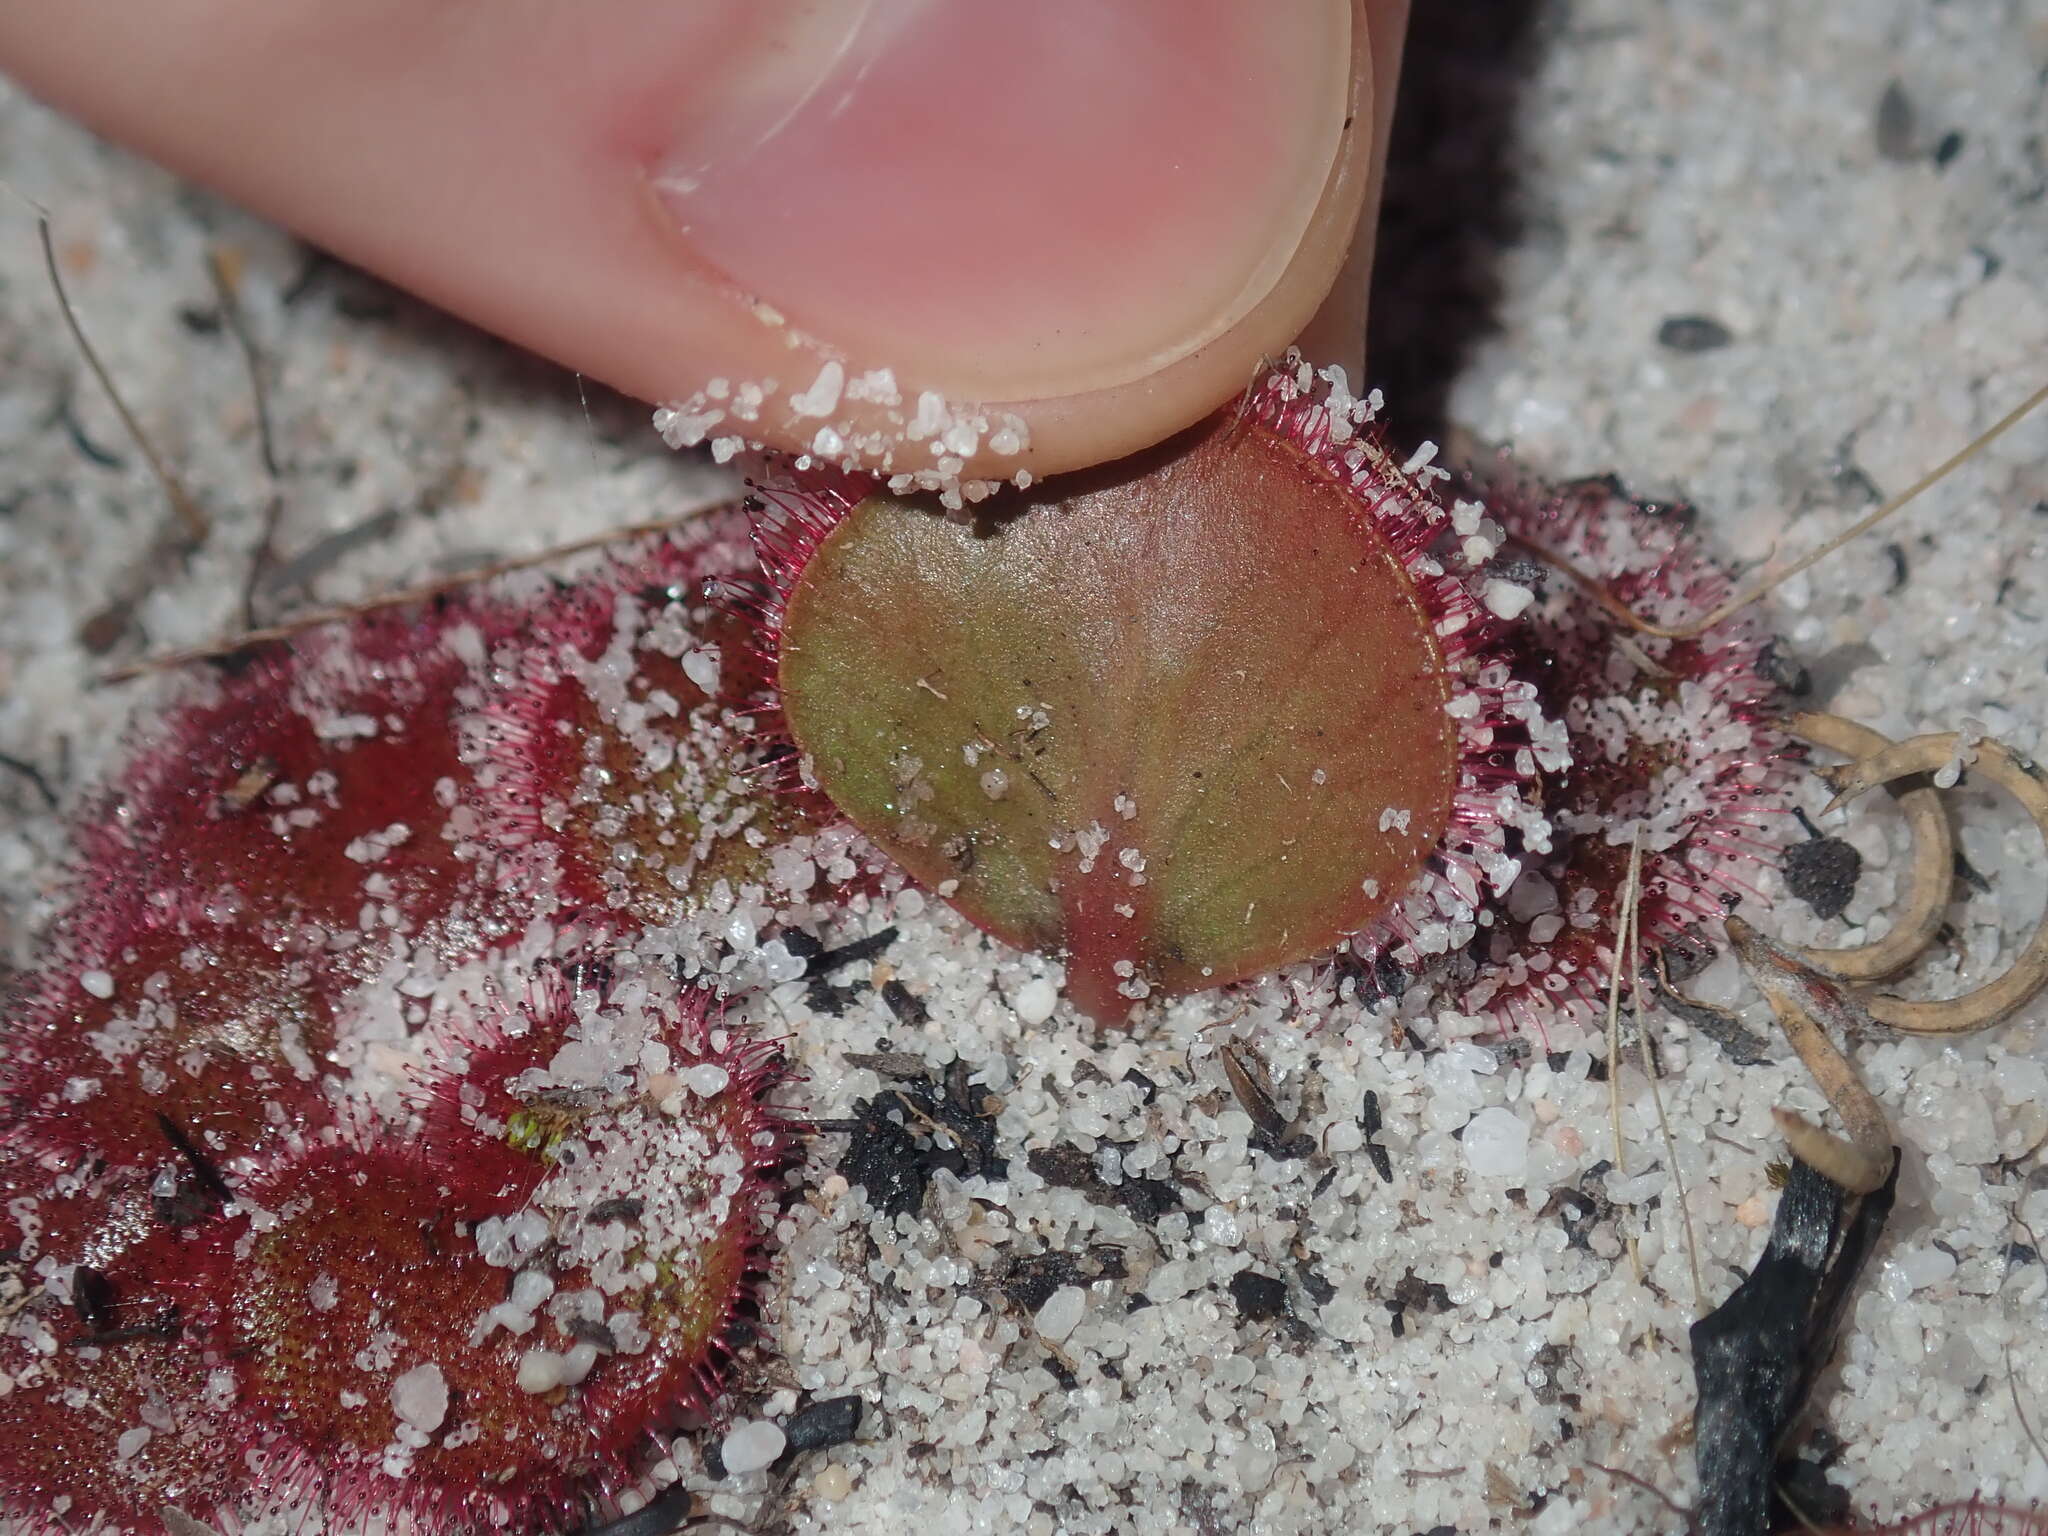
xmin=0 ymin=0 xmax=1407 ymax=475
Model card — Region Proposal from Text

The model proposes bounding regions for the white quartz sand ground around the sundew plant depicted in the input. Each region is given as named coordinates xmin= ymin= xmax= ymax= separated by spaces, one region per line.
xmin=0 ymin=0 xmax=2048 ymax=1536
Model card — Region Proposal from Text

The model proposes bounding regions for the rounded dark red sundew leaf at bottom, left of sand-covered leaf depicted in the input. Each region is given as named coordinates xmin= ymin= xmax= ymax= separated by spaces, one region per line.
xmin=209 ymin=1145 xmax=598 ymax=1520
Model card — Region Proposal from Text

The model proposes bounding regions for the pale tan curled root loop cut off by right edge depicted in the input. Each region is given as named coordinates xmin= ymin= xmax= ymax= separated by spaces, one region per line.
xmin=1827 ymin=731 xmax=2048 ymax=1034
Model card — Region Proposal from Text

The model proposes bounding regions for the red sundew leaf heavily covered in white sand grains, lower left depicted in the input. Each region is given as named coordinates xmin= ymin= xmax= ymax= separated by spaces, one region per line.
xmin=407 ymin=967 xmax=786 ymax=1490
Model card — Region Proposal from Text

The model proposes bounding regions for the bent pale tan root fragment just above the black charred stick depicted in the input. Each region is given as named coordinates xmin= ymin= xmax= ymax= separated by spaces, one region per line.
xmin=1729 ymin=918 xmax=1892 ymax=1194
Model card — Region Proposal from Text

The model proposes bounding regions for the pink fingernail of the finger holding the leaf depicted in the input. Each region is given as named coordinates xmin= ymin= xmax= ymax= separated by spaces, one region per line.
xmin=653 ymin=0 xmax=1352 ymax=401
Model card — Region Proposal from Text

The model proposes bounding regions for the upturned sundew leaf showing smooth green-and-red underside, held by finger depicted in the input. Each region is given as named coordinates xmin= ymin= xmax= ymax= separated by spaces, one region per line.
xmin=778 ymin=395 xmax=1483 ymax=1018
